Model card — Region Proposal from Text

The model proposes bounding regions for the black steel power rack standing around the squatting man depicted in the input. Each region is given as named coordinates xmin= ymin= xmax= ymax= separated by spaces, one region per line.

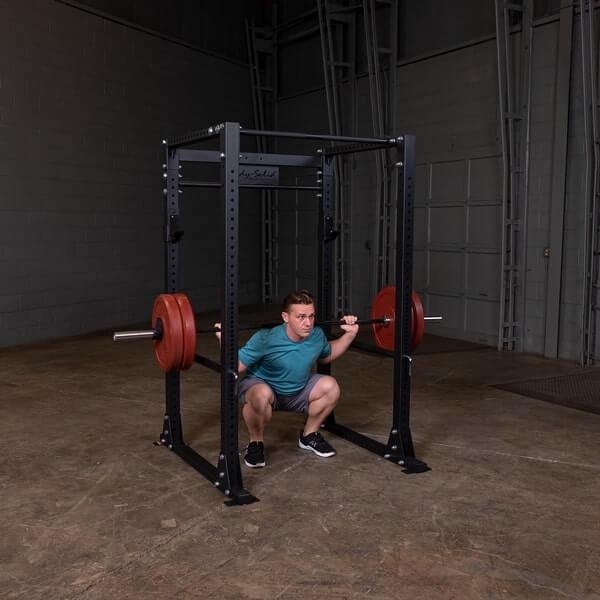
xmin=160 ymin=122 xmax=429 ymax=505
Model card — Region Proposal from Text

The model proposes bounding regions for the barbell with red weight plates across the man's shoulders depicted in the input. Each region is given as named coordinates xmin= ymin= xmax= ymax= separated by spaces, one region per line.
xmin=113 ymin=286 xmax=442 ymax=372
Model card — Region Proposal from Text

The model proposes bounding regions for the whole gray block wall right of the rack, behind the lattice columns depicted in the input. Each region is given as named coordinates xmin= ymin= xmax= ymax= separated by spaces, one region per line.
xmin=398 ymin=17 xmax=596 ymax=360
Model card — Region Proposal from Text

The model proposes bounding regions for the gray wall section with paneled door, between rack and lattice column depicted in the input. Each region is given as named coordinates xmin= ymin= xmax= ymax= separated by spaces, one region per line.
xmin=397 ymin=41 xmax=502 ymax=345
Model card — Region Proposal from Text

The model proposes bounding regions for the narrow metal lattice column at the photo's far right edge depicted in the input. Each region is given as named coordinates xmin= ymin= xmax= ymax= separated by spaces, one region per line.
xmin=579 ymin=0 xmax=600 ymax=366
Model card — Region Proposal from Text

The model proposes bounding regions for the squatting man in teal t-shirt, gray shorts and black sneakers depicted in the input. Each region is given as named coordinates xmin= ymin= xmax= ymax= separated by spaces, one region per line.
xmin=215 ymin=290 xmax=358 ymax=468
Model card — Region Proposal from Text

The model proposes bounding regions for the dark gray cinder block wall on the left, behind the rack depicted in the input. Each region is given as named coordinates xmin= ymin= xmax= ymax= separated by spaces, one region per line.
xmin=0 ymin=0 xmax=260 ymax=346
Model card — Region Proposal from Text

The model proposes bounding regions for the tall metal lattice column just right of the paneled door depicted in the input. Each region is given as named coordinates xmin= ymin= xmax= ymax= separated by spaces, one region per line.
xmin=495 ymin=0 xmax=533 ymax=351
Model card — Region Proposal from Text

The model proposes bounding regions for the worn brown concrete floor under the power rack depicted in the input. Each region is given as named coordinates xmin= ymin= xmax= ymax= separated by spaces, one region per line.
xmin=0 ymin=312 xmax=600 ymax=600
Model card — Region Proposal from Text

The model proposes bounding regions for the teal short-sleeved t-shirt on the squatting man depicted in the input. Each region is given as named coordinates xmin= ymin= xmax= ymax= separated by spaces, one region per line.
xmin=239 ymin=323 xmax=331 ymax=396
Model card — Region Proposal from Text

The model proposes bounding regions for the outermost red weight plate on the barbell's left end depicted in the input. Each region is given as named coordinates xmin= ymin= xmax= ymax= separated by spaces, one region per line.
xmin=152 ymin=294 xmax=183 ymax=373
